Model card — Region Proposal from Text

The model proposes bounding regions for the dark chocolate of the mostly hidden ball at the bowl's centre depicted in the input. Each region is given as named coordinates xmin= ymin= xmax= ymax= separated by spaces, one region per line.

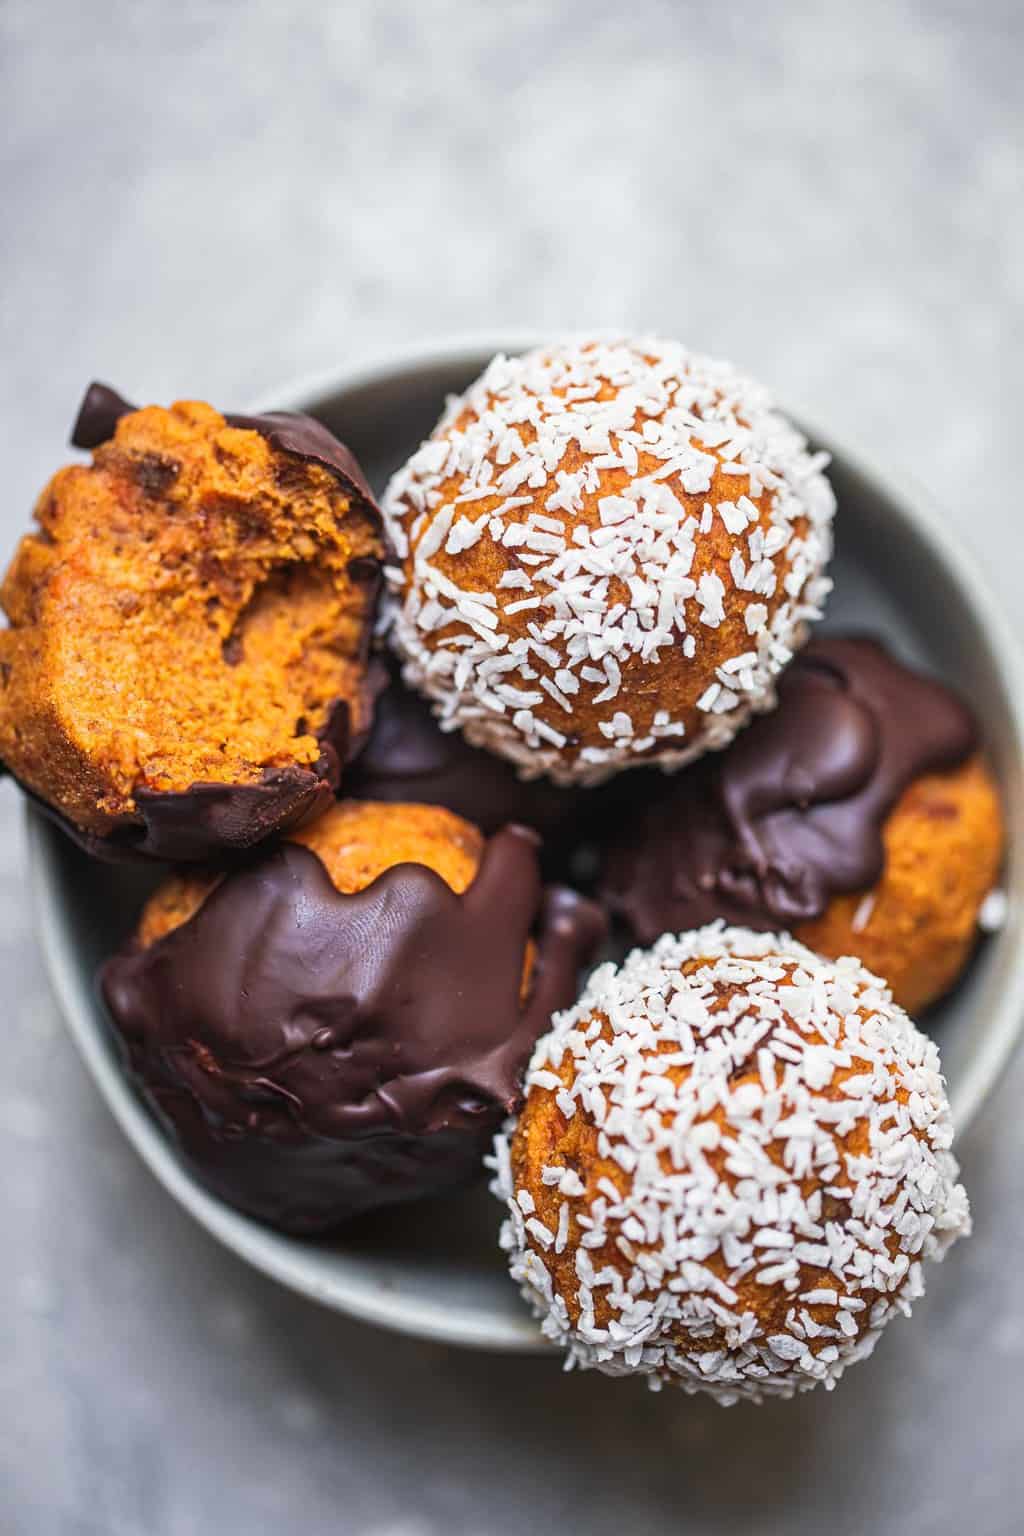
xmin=345 ymin=665 xmax=588 ymax=839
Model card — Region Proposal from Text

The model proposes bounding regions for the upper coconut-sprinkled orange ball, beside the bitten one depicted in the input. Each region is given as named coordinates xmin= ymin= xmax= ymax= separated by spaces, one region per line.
xmin=384 ymin=339 xmax=835 ymax=785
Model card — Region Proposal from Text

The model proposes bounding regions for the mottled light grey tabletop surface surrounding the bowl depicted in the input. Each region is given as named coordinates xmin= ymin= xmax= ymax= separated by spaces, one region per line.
xmin=0 ymin=0 xmax=1024 ymax=1536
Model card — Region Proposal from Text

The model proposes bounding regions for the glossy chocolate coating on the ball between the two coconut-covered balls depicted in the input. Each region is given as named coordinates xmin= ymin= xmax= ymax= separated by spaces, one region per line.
xmin=600 ymin=637 xmax=978 ymax=943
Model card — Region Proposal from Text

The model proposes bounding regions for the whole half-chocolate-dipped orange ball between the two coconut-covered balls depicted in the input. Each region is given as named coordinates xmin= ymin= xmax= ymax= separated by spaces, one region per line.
xmin=600 ymin=636 xmax=1004 ymax=1014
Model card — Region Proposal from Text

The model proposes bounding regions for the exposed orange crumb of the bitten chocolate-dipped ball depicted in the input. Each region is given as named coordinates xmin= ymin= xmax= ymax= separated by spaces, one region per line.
xmin=0 ymin=401 xmax=382 ymax=834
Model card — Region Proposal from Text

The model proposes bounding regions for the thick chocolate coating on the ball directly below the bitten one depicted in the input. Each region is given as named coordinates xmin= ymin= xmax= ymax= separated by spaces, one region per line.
xmin=100 ymin=826 xmax=605 ymax=1232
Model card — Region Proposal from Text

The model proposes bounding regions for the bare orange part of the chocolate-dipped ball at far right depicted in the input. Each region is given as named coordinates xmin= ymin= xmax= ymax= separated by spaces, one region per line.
xmin=795 ymin=757 xmax=1004 ymax=1015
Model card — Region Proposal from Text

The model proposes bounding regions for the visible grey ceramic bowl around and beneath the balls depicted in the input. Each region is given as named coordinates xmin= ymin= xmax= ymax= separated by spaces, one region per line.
xmin=29 ymin=347 xmax=1024 ymax=1350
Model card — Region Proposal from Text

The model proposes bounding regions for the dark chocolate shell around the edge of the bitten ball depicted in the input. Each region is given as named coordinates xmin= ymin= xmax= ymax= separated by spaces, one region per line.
xmin=7 ymin=382 xmax=384 ymax=863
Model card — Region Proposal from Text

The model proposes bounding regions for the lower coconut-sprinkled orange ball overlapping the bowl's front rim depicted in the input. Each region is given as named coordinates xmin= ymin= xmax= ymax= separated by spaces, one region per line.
xmin=496 ymin=923 xmax=970 ymax=1404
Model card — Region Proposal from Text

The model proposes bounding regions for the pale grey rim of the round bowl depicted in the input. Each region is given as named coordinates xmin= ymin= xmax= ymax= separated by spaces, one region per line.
xmin=26 ymin=330 xmax=1024 ymax=1353
